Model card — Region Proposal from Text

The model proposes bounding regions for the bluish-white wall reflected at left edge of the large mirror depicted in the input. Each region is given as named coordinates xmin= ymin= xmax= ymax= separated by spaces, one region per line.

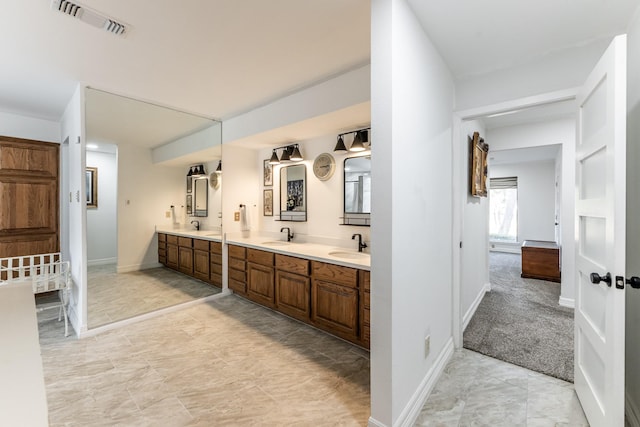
xmin=87 ymin=151 xmax=118 ymax=265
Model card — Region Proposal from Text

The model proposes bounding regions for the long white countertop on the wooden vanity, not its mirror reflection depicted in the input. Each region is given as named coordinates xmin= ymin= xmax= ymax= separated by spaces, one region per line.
xmin=225 ymin=236 xmax=371 ymax=270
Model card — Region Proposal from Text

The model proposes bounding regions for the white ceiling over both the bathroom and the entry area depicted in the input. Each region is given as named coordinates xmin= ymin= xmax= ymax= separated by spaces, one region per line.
xmin=0 ymin=0 xmax=638 ymax=153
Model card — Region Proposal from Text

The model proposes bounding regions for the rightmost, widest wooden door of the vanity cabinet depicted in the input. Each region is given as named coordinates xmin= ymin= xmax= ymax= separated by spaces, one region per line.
xmin=311 ymin=280 xmax=358 ymax=340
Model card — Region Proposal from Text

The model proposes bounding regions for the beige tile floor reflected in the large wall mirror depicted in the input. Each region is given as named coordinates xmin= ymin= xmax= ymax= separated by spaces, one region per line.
xmin=87 ymin=264 xmax=221 ymax=329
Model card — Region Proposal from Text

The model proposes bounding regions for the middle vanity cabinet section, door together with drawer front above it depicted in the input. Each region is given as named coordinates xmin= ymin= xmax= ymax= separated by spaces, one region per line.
xmin=275 ymin=254 xmax=311 ymax=322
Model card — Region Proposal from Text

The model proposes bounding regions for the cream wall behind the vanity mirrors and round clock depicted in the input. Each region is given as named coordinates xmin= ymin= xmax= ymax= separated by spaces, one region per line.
xmin=256 ymin=133 xmax=375 ymax=249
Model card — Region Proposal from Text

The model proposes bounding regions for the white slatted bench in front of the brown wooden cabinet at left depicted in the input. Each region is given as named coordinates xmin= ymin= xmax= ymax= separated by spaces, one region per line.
xmin=0 ymin=252 xmax=71 ymax=337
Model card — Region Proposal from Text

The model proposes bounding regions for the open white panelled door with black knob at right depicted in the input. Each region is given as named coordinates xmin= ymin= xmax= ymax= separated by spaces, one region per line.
xmin=575 ymin=35 xmax=627 ymax=427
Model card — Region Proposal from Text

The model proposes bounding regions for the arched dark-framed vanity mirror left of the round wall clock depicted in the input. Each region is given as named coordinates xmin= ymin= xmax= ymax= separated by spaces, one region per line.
xmin=280 ymin=165 xmax=307 ymax=221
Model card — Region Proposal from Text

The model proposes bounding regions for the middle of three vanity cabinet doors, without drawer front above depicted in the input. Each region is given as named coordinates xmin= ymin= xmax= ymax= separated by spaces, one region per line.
xmin=276 ymin=271 xmax=311 ymax=322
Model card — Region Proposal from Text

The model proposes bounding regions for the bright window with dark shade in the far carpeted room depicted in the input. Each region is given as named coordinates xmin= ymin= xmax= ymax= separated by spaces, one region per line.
xmin=489 ymin=176 xmax=518 ymax=242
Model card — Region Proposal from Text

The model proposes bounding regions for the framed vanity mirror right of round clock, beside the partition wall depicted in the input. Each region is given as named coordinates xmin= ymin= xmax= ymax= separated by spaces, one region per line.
xmin=344 ymin=156 xmax=371 ymax=226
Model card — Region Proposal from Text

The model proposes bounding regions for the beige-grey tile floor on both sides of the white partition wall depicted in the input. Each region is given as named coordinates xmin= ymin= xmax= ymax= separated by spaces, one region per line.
xmin=39 ymin=276 xmax=587 ymax=427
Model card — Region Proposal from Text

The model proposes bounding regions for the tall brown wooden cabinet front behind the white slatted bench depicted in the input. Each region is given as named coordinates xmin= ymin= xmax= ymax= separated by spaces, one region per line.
xmin=0 ymin=137 xmax=60 ymax=257
